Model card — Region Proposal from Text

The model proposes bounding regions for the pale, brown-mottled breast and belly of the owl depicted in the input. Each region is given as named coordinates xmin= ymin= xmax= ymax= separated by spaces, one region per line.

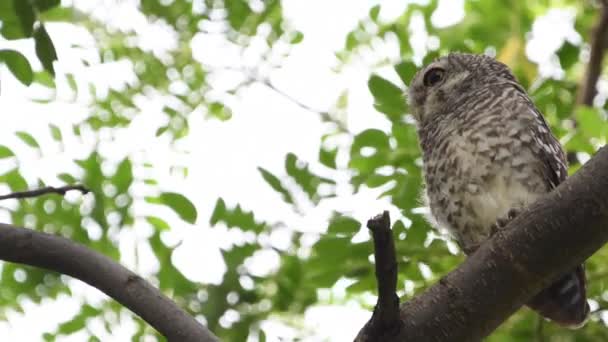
xmin=424 ymin=124 xmax=546 ymax=247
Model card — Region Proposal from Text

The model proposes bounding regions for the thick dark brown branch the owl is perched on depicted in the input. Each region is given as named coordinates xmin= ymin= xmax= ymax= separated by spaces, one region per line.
xmin=358 ymin=147 xmax=608 ymax=342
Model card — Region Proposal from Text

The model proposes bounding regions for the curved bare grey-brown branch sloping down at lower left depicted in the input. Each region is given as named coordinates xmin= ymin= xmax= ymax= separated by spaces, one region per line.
xmin=0 ymin=224 xmax=218 ymax=342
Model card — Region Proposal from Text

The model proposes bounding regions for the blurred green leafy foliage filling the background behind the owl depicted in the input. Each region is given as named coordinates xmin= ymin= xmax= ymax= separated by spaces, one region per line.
xmin=0 ymin=0 xmax=608 ymax=341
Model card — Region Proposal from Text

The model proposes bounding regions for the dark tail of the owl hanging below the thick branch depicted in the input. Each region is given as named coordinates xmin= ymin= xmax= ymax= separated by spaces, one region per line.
xmin=528 ymin=265 xmax=589 ymax=328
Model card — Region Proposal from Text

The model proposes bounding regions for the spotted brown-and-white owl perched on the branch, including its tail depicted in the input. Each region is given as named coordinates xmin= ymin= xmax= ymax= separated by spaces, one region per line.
xmin=408 ymin=53 xmax=589 ymax=327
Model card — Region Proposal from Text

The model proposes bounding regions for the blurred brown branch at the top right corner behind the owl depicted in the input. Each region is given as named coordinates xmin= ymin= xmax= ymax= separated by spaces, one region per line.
xmin=576 ymin=0 xmax=608 ymax=106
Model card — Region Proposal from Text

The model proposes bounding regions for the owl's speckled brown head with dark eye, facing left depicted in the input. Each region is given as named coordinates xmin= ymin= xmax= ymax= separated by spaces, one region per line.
xmin=408 ymin=53 xmax=516 ymax=123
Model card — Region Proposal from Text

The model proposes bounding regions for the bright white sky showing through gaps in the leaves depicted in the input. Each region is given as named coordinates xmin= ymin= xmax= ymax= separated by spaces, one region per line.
xmin=0 ymin=0 xmax=580 ymax=341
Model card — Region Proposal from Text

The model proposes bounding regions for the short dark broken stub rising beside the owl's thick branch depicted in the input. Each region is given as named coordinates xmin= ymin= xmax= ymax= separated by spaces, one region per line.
xmin=355 ymin=211 xmax=402 ymax=341
